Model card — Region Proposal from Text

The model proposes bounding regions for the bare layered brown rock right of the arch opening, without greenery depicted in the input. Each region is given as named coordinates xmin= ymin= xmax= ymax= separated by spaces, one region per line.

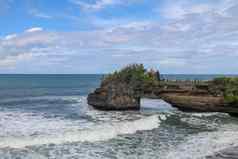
xmin=159 ymin=81 xmax=238 ymax=116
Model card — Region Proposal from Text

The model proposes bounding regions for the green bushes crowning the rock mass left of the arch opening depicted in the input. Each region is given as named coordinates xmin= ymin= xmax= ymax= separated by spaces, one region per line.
xmin=103 ymin=64 xmax=159 ymax=87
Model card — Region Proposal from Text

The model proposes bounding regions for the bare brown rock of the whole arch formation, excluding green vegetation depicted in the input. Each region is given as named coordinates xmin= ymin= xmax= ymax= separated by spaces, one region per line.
xmin=88 ymin=81 xmax=238 ymax=116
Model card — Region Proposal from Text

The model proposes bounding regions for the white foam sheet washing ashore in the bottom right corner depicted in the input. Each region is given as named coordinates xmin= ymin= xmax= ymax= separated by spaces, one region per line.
xmin=166 ymin=124 xmax=238 ymax=159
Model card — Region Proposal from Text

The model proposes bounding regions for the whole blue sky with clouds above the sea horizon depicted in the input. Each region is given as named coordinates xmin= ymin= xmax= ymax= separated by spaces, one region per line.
xmin=0 ymin=0 xmax=238 ymax=74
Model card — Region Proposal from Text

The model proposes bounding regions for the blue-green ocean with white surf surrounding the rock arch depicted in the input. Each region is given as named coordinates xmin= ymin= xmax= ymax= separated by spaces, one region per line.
xmin=0 ymin=75 xmax=238 ymax=159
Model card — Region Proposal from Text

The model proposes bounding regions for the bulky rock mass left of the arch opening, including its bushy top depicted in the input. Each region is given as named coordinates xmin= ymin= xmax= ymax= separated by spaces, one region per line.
xmin=88 ymin=64 xmax=159 ymax=110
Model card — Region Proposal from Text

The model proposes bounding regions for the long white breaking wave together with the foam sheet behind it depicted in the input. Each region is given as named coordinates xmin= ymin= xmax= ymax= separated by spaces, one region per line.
xmin=0 ymin=112 xmax=164 ymax=148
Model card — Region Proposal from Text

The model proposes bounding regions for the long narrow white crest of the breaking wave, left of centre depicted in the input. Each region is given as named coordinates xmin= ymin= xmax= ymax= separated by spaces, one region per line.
xmin=0 ymin=115 xmax=161 ymax=148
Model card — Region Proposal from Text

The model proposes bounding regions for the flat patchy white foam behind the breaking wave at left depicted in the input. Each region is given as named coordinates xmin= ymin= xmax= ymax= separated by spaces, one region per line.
xmin=0 ymin=111 xmax=87 ymax=137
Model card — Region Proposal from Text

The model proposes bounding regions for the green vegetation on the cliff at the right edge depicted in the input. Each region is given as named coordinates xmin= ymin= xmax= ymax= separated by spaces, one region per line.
xmin=213 ymin=77 xmax=238 ymax=105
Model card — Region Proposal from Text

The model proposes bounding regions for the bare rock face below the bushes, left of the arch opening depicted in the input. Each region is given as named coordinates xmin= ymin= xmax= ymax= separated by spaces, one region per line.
xmin=88 ymin=82 xmax=140 ymax=110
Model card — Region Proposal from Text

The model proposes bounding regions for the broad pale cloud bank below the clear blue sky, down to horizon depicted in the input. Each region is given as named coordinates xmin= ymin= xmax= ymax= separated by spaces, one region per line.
xmin=0 ymin=0 xmax=238 ymax=73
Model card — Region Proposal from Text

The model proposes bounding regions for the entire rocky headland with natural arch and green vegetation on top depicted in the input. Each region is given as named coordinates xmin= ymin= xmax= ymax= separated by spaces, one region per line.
xmin=88 ymin=65 xmax=238 ymax=116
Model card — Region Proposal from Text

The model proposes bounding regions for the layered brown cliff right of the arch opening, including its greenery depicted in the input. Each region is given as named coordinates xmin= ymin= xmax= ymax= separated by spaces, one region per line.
xmin=159 ymin=78 xmax=238 ymax=116
